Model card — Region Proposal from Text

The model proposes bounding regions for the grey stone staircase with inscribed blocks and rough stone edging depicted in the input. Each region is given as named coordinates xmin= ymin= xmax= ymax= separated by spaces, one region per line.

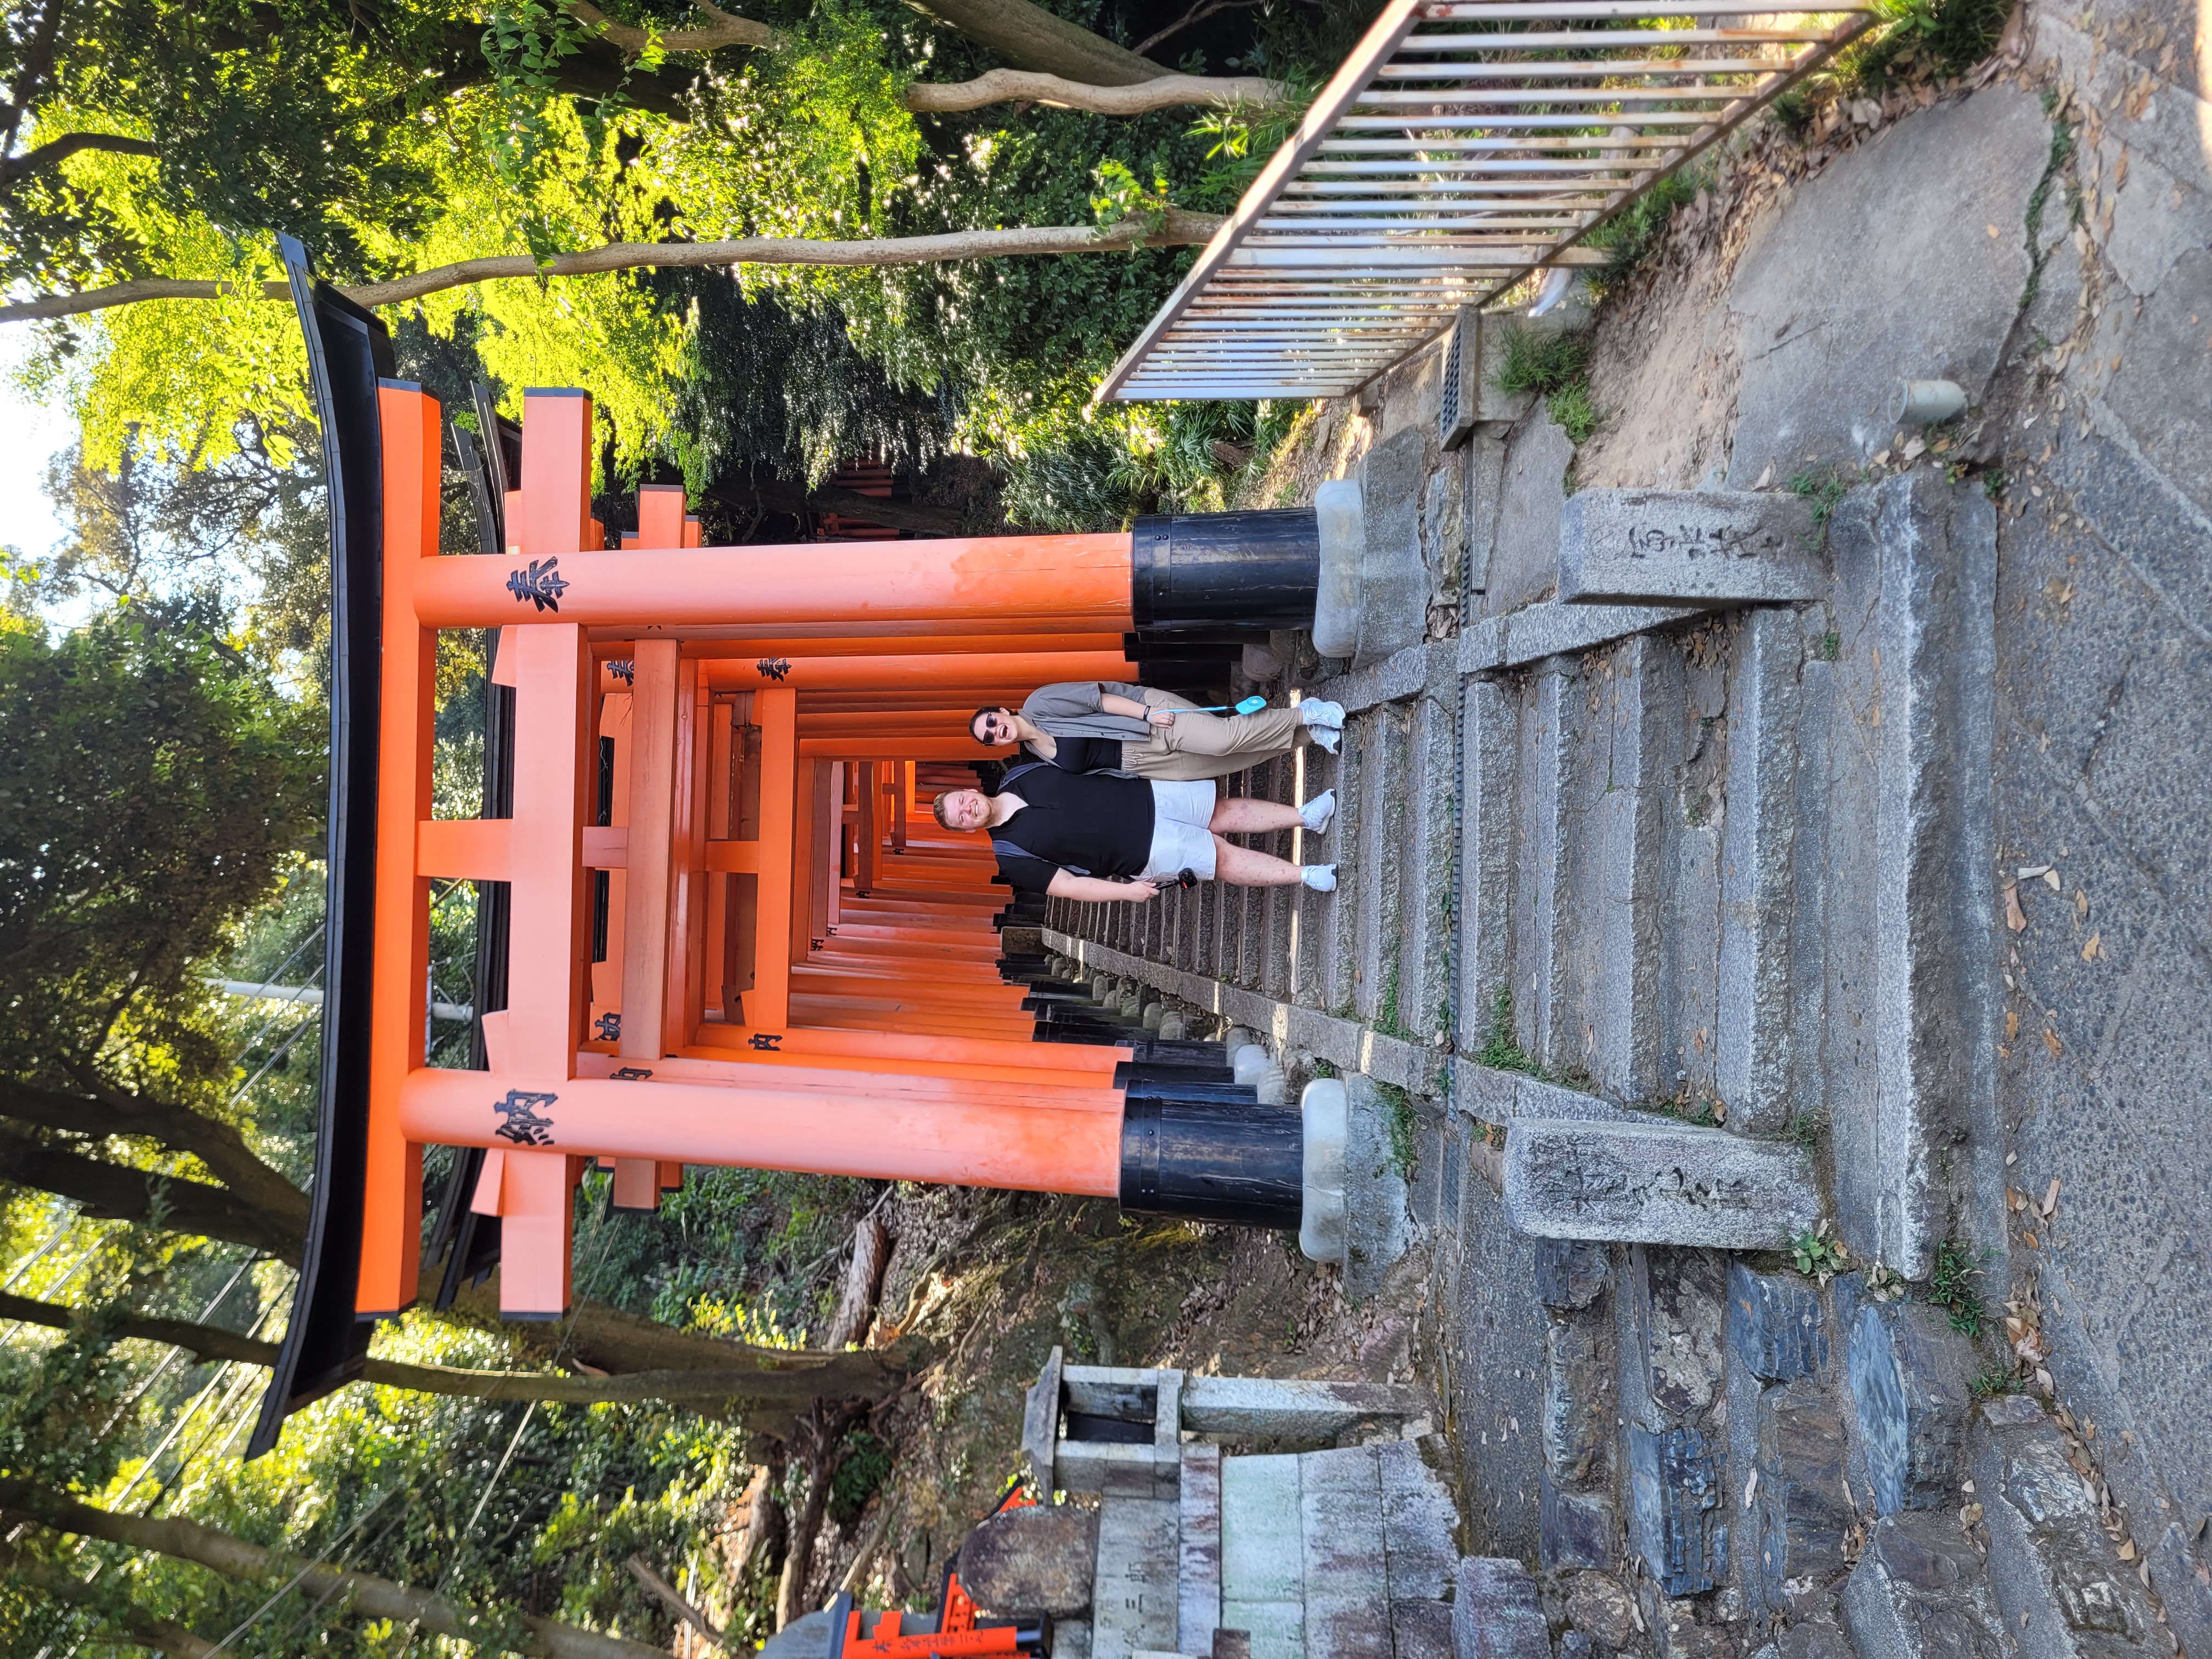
xmin=1044 ymin=449 xmax=2176 ymax=1659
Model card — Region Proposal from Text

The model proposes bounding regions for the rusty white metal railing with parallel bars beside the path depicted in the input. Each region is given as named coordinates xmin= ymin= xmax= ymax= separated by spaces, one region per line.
xmin=1097 ymin=0 xmax=1874 ymax=400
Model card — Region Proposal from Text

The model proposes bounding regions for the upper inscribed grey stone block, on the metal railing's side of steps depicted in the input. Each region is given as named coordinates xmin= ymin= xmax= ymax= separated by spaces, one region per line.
xmin=1560 ymin=489 xmax=1827 ymax=604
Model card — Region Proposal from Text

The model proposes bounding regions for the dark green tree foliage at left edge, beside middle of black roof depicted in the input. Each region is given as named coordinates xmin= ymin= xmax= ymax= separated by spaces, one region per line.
xmin=0 ymin=597 xmax=325 ymax=1093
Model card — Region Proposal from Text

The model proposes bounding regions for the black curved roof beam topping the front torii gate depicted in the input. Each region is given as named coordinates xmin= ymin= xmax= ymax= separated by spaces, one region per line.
xmin=246 ymin=236 xmax=396 ymax=1458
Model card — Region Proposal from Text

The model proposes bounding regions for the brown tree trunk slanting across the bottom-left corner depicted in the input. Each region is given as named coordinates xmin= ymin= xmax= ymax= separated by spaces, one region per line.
xmin=0 ymin=1480 xmax=668 ymax=1659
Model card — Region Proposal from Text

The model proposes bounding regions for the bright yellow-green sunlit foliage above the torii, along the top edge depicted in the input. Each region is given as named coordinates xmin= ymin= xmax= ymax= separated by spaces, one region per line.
xmin=13 ymin=0 xmax=1372 ymax=522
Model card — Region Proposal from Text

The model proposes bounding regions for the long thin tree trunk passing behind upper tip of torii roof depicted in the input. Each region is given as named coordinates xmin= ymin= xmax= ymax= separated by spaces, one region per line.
xmin=0 ymin=208 xmax=1221 ymax=323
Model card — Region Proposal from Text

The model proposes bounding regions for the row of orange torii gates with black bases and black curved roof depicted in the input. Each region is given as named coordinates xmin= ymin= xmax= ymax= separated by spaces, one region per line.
xmin=252 ymin=244 xmax=1321 ymax=1451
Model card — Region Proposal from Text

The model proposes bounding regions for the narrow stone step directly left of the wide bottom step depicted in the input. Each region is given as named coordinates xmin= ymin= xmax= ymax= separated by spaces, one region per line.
xmin=1714 ymin=611 xmax=1805 ymax=1135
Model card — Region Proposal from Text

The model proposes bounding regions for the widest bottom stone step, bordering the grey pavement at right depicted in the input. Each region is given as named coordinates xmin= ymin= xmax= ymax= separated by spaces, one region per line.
xmin=1827 ymin=473 xmax=2000 ymax=1278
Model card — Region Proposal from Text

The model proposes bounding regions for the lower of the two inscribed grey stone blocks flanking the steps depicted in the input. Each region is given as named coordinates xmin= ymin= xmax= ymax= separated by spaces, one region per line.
xmin=1504 ymin=1117 xmax=1820 ymax=1250
